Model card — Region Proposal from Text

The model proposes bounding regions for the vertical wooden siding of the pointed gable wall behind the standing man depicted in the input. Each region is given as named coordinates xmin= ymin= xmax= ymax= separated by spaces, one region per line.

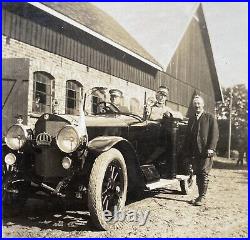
xmin=164 ymin=15 xmax=219 ymax=112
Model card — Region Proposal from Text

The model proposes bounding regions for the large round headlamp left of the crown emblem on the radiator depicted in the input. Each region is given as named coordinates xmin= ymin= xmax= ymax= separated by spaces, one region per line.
xmin=5 ymin=124 xmax=29 ymax=150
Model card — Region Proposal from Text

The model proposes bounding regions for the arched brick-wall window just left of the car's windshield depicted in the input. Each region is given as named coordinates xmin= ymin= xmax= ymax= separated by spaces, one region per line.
xmin=65 ymin=80 xmax=83 ymax=115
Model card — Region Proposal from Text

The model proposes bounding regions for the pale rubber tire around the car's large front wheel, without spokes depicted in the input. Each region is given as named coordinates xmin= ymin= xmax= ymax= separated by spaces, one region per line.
xmin=88 ymin=148 xmax=128 ymax=230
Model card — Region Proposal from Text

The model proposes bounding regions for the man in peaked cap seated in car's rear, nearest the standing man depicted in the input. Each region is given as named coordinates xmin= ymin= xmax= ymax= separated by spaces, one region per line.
xmin=149 ymin=86 xmax=183 ymax=120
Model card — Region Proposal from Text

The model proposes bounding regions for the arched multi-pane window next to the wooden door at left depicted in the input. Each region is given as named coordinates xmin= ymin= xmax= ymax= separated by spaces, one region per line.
xmin=32 ymin=72 xmax=55 ymax=113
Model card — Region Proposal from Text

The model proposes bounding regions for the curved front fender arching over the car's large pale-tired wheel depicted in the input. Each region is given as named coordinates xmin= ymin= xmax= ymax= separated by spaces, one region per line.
xmin=88 ymin=136 xmax=145 ymax=193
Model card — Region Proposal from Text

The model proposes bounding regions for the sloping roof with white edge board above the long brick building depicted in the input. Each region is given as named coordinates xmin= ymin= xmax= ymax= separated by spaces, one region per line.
xmin=29 ymin=2 xmax=162 ymax=70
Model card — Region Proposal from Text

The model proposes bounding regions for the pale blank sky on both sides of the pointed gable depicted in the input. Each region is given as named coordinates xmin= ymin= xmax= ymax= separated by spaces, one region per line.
xmin=93 ymin=2 xmax=248 ymax=87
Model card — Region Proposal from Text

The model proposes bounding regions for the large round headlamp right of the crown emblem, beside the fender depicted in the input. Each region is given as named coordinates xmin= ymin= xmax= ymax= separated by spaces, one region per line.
xmin=56 ymin=125 xmax=81 ymax=153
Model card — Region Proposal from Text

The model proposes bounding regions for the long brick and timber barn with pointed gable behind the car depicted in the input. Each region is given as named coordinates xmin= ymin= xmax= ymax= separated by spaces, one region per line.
xmin=2 ymin=2 xmax=222 ymax=134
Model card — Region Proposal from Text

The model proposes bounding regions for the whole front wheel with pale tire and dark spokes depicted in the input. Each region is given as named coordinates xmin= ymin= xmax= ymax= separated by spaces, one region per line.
xmin=88 ymin=148 xmax=128 ymax=230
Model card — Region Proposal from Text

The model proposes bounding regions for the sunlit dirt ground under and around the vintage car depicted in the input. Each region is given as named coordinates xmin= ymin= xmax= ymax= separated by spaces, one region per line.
xmin=2 ymin=158 xmax=248 ymax=238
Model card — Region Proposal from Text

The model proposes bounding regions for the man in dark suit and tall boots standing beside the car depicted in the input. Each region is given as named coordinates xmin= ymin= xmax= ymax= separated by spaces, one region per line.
xmin=185 ymin=95 xmax=219 ymax=206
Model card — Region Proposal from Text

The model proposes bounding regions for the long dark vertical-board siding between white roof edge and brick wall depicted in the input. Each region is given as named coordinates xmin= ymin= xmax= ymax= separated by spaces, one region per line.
xmin=3 ymin=4 xmax=157 ymax=90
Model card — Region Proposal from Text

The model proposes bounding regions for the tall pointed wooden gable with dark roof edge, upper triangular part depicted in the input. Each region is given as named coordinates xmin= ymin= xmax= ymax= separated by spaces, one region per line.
xmin=166 ymin=4 xmax=223 ymax=108
